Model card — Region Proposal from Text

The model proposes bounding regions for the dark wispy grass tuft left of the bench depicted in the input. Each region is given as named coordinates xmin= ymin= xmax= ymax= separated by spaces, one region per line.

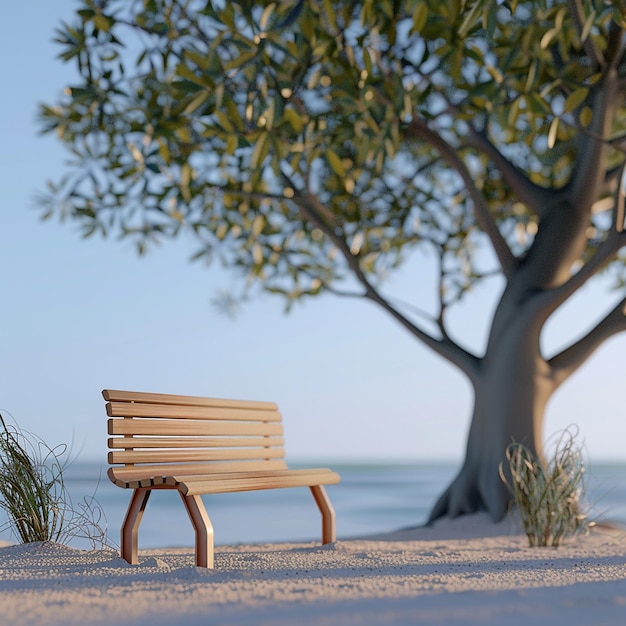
xmin=0 ymin=414 xmax=106 ymax=548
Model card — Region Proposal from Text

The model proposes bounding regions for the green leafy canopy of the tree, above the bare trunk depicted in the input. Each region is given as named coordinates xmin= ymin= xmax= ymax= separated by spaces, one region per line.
xmin=41 ymin=0 xmax=624 ymax=306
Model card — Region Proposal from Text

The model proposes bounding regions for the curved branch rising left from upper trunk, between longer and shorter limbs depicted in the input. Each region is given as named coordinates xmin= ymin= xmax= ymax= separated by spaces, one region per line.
xmin=407 ymin=119 xmax=517 ymax=277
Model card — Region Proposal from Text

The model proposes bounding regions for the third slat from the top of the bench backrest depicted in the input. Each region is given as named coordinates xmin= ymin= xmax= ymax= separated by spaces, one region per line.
xmin=108 ymin=418 xmax=283 ymax=437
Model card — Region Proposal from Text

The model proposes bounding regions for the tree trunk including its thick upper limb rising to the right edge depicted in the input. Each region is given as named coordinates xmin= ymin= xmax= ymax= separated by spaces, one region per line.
xmin=422 ymin=64 xmax=624 ymax=521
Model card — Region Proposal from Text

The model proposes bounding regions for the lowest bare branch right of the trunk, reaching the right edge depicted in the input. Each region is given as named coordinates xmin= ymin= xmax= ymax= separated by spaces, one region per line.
xmin=548 ymin=297 xmax=626 ymax=387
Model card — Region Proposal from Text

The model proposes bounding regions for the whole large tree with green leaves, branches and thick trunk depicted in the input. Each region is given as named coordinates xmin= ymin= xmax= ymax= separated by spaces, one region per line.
xmin=41 ymin=0 xmax=626 ymax=520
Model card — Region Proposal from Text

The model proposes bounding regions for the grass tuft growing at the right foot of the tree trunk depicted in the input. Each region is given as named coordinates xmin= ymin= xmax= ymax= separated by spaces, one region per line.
xmin=500 ymin=429 xmax=586 ymax=548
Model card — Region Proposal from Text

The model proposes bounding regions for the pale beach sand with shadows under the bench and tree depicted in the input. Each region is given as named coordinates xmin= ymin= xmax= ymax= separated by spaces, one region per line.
xmin=0 ymin=514 xmax=626 ymax=626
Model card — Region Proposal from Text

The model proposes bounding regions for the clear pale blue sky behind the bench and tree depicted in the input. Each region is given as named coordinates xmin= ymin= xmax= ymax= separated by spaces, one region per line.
xmin=0 ymin=0 xmax=626 ymax=464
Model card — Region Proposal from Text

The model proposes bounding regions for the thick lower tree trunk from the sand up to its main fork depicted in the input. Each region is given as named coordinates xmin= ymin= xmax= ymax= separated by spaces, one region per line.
xmin=429 ymin=289 xmax=556 ymax=521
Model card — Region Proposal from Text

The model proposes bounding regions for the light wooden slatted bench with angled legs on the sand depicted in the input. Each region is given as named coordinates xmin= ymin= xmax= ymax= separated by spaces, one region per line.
xmin=102 ymin=389 xmax=340 ymax=568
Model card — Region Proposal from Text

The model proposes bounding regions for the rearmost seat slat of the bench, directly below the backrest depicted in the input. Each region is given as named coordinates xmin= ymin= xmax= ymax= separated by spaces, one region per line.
xmin=107 ymin=460 xmax=287 ymax=482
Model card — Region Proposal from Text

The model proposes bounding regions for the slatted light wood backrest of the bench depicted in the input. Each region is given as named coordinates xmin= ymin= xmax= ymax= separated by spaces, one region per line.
xmin=102 ymin=389 xmax=287 ymax=478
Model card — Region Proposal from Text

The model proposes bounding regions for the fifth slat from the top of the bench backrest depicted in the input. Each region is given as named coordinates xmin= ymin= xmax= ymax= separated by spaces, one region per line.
xmin=109 ymin=448 xmax=285 ymax=465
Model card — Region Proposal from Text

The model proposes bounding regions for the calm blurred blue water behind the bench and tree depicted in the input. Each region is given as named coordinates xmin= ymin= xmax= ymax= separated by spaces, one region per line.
xmin=0 ymin=462 xmax=626 ymax=548
